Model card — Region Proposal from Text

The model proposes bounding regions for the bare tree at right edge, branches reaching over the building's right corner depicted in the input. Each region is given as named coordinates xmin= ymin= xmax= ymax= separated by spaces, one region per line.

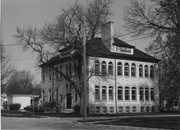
xmin=125 ymin=0 xmax=180 ymax=105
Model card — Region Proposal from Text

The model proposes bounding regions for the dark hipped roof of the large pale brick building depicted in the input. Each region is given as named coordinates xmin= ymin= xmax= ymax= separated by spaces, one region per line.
xmin=40 ymin=38 xmax=160 ymax=66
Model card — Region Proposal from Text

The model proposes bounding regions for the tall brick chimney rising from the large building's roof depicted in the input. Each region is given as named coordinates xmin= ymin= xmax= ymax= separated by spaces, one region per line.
xmin=101 ymin=21 xmax=116 ymax=52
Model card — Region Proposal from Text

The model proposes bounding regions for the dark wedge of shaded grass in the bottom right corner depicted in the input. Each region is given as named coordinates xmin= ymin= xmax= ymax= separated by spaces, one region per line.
xmin=94 ymin=117 xmax=180 ymax=130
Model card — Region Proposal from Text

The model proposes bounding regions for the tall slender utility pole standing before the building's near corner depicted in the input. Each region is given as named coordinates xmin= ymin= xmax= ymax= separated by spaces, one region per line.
xmin=83 ymin=18 xmax=87 ymax=121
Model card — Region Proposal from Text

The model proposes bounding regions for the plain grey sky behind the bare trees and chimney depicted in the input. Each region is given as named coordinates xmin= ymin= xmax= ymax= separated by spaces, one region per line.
xmin=1 ymin=0 xmax=149 ymax=82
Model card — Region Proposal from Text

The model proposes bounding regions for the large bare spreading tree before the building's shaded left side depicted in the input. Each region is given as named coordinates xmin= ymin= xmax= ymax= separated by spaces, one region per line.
xmin=15 ymin=0 xmax=112 ymax=114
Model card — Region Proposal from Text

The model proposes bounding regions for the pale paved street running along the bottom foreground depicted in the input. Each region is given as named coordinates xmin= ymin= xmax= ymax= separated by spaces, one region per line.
xmin=1 ymin=117 xmax=165 ymax=130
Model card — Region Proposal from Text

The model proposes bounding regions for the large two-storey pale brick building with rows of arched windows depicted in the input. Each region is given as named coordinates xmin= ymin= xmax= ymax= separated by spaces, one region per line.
xmin=41 ymin=22 xmax=159 ymax=113
